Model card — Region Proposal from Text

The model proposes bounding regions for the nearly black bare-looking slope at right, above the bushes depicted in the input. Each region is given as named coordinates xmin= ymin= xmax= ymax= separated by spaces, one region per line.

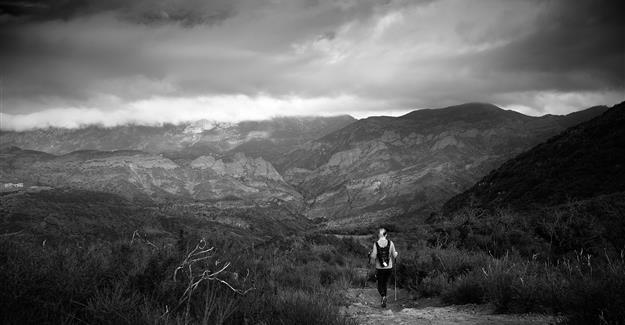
xmin=445 ymin=102 xmax=625 ymax=213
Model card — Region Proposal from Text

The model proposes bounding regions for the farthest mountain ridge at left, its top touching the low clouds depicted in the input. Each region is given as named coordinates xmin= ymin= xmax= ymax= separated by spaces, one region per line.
xmin=0 ymin=115 xmax=355 ymax=162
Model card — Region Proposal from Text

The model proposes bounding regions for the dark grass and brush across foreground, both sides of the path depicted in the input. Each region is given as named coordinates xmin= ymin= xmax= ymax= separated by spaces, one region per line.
xmin=0 ymin=196 xmax=625 ymax=324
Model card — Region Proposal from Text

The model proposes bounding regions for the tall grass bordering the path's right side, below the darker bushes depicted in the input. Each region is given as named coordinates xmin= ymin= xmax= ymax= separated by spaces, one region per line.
xmin=398 ymin=243 xmax=625 ymax=324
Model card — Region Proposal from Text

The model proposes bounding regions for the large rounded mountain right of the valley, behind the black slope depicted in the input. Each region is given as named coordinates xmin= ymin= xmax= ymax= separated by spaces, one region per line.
xmin=275 ymin=103 xmax=607 ymax=227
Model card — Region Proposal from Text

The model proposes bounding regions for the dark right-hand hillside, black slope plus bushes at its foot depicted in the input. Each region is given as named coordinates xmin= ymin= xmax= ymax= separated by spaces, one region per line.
xmin=430 ymin=103 xmax=625 ymax=258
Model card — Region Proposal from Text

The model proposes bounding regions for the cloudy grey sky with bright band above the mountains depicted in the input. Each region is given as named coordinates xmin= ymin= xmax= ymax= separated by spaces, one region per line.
xmin=0 ymin=0 xmax=625 ymax=130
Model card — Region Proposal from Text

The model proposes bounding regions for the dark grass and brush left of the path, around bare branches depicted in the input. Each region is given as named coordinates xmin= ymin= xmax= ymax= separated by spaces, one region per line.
xmin=0 ymin=232 xmax=361 ymax=324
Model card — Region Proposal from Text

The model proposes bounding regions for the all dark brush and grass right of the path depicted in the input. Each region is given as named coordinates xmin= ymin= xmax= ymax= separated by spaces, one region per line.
xmin=348 ymin=199 xmax=625 ymax=324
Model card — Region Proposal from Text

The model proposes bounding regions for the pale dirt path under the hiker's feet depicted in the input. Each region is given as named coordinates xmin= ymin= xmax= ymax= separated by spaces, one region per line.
xmin=342 ymin=288 xmax=556 ymax=325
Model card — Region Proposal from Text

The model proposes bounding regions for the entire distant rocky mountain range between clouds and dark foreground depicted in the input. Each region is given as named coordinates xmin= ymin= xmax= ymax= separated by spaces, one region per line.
xmin=0 ymin=103 xmax=607 ymax=227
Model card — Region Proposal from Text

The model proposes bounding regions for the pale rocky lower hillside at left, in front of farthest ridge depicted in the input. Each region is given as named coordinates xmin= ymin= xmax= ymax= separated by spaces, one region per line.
xmin=0 ymin=147 xmax=301 ymax=209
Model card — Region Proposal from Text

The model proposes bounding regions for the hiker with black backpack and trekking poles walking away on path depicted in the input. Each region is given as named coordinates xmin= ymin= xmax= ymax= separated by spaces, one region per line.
xmin=369 ymin=227 xmax=398 ymax=308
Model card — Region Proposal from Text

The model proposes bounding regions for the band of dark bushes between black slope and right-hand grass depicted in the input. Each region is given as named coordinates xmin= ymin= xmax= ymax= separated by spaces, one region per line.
xmin=425 ymin=193 xmax=625 ymax=260
